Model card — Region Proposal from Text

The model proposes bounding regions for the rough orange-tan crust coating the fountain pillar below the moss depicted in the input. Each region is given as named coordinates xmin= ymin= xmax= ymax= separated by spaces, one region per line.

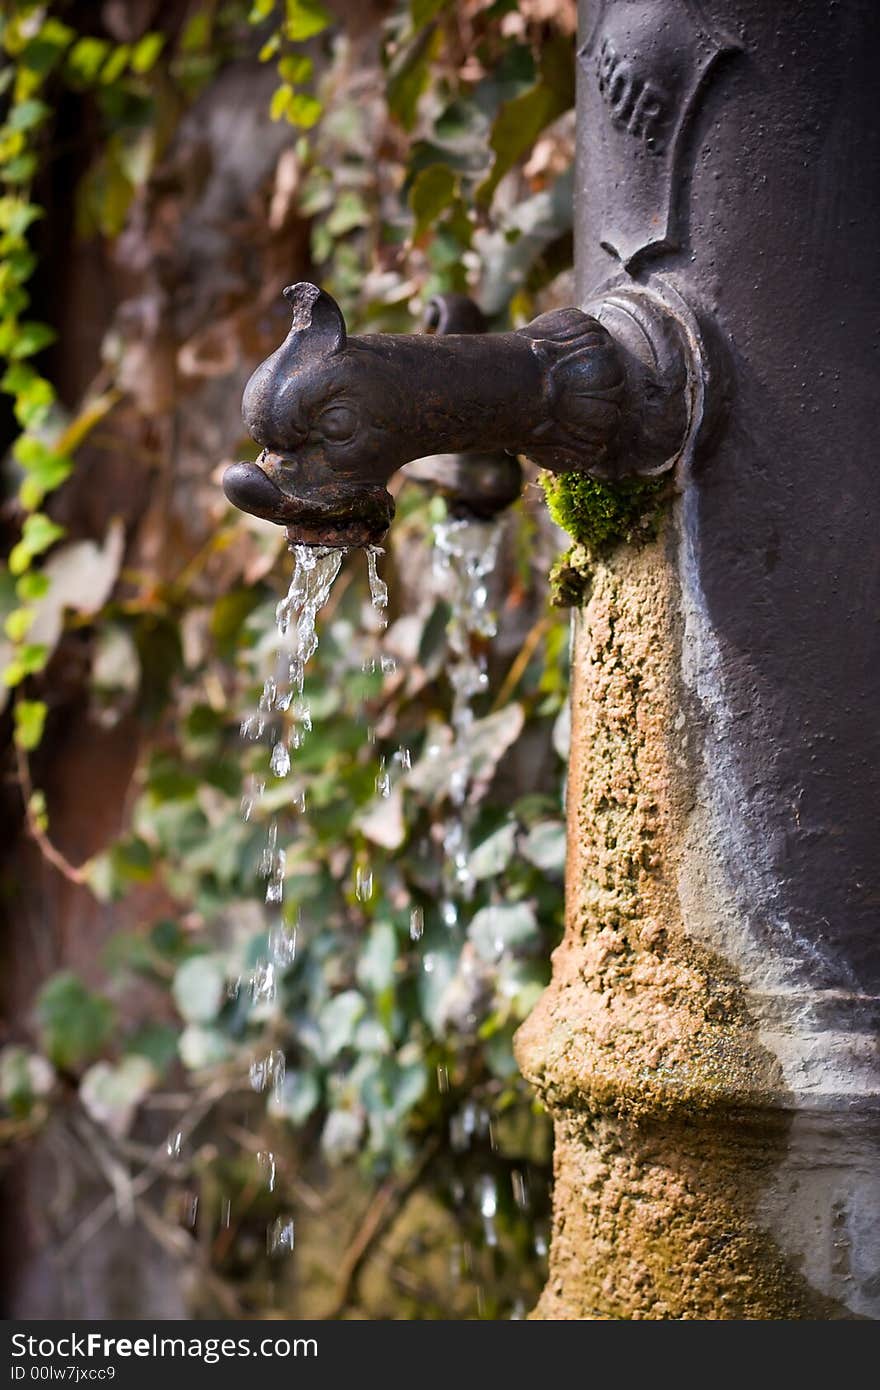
xmin=516 ymin=535 xmax=848 ymax=1319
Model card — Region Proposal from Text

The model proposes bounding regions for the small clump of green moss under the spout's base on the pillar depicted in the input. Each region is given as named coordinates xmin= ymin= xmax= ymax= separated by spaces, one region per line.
xmin=541 ymin=473 xmax=669 ymax=607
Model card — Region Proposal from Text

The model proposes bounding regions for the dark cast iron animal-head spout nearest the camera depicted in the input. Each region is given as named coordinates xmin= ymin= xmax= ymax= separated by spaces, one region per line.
xmin=224 ymin=284 xmax=700 ymax=545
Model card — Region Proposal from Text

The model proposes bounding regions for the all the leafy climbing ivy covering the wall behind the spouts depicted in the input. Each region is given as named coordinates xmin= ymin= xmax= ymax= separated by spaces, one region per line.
xmin=0 ymin=0 xmax=574 ymax=1316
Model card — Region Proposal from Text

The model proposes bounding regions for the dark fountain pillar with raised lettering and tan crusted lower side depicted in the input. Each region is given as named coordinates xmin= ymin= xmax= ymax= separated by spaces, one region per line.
xmin=519 ymin=0 xmax=880 ymax=1319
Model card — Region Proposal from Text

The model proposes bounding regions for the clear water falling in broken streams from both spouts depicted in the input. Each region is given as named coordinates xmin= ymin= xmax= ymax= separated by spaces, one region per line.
xmin=225 ymin=518 xmax=542 ymax=1316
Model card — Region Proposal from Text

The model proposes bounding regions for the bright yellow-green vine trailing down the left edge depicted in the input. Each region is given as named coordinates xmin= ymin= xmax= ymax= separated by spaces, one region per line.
xmin=0 ymin=0 xmax=164 ymax=733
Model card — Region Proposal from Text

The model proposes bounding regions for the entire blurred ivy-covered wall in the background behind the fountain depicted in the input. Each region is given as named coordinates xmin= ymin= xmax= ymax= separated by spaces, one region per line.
xmin=0 ymin=0 xmax=574 ymax=1318
